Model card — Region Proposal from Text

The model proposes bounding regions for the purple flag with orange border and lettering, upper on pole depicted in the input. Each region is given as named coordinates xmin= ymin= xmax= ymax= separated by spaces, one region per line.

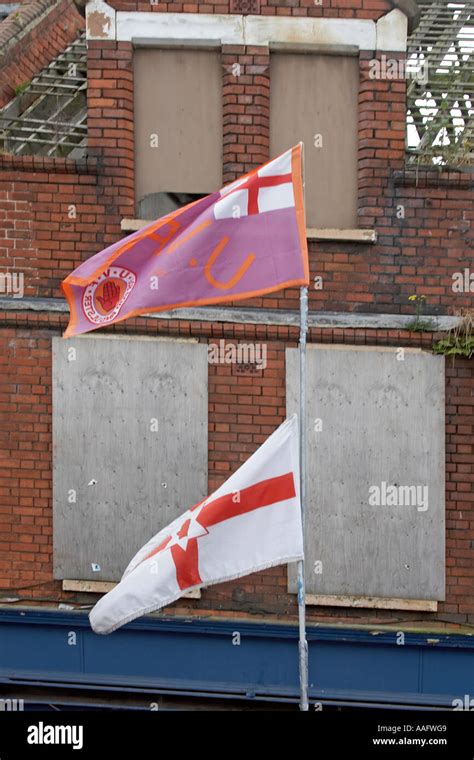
xmin=62 ymin=144 xmax=309 ymax=338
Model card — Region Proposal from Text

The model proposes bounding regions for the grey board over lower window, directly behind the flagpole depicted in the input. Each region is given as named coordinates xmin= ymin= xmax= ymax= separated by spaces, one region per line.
xmin=286 ymin=346 xmax=445 ymax=601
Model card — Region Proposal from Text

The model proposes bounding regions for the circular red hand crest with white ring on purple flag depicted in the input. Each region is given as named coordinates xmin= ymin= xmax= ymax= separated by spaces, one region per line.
xmin=82 ymin=267 xmax=137 ymax=325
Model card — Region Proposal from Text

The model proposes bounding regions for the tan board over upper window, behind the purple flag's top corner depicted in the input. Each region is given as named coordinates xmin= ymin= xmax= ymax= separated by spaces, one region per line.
xmin=270 ymin=53 xmax=359 ymax=229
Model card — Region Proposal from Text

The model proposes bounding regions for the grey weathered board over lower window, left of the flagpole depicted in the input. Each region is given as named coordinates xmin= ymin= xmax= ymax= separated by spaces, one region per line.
xmin=53 ymin=337 xmax=207 ymax=581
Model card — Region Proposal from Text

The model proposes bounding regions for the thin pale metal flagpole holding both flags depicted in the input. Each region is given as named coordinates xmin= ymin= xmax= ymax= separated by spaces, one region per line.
xmin=297 ymin=143 xmax=309 ymax=712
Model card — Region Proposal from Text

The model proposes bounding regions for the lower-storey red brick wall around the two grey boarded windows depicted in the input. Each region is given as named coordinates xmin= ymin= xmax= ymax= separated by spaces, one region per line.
xmin=0 ymin=311 xmax=474 ymax=625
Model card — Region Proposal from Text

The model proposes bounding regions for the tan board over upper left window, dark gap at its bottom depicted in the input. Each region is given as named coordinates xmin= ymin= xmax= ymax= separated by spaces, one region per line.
xmin=134 ymin=49 xmax=222 ymax=216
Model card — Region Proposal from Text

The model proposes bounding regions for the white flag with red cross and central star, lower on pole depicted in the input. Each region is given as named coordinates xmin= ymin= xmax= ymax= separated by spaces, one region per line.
xmin=89 ymin=415 xmax=303 ymax=633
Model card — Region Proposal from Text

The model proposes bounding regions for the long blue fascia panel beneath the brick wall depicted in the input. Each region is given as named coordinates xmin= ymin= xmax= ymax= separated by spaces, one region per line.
xmin=0 ymin=608 xmax=474 ymax=707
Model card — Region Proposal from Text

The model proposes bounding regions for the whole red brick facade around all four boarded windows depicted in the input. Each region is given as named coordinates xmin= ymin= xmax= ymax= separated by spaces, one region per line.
xmin=0 ymin=0 xmax=474 ymax=624
